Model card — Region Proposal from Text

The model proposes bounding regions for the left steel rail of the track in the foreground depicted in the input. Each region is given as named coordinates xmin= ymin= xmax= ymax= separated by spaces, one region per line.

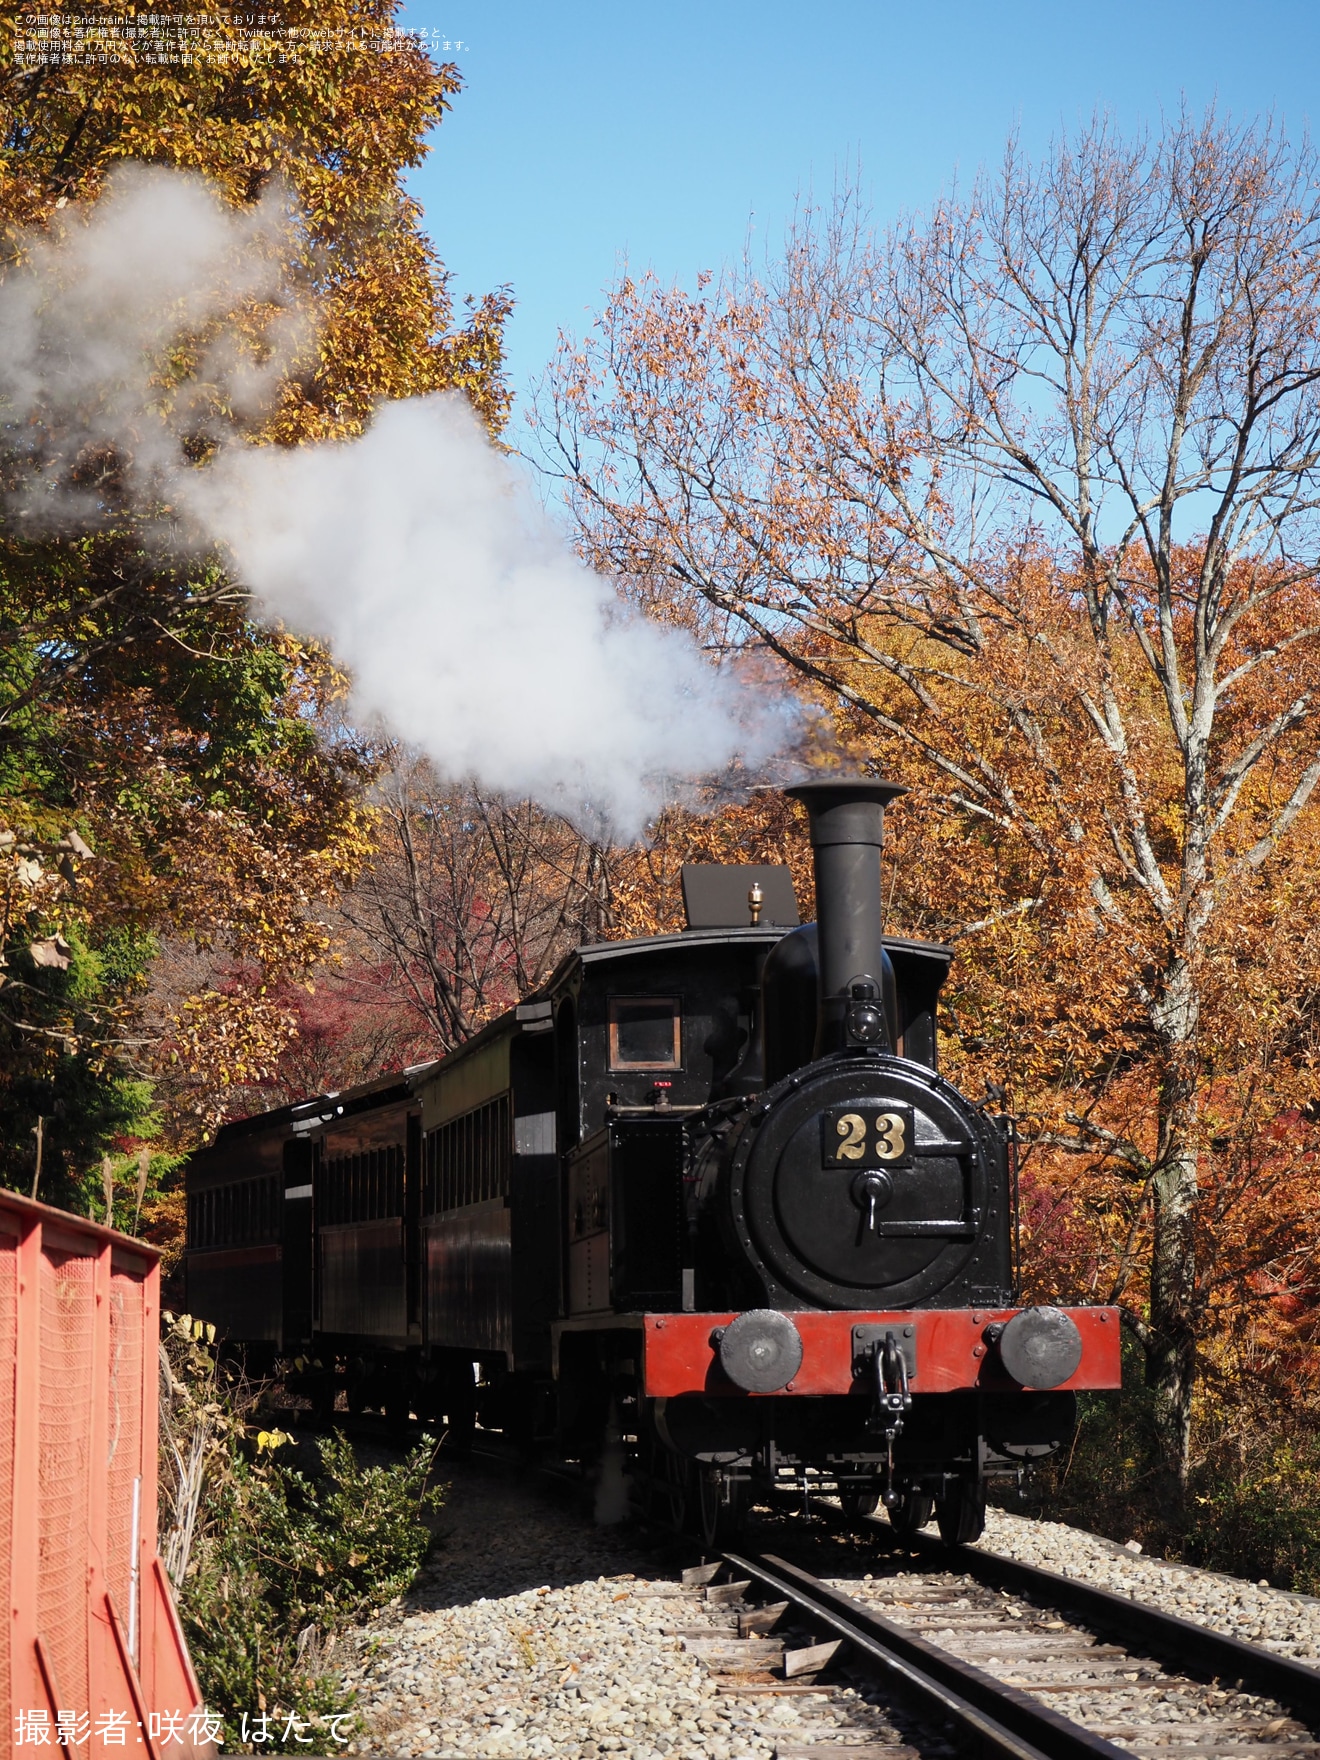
xmin=723 ymin=1552 xmax=1132 ymax=1760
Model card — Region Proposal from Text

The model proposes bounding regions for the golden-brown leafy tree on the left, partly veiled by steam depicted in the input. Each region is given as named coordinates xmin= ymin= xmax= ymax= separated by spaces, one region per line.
xmin=0 ymin=0 xmax=509 ymax=1197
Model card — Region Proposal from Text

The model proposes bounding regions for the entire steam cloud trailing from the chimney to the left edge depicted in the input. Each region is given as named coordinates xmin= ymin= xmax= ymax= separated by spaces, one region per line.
xmin=0 ymin=167 xmax=792 ymax=834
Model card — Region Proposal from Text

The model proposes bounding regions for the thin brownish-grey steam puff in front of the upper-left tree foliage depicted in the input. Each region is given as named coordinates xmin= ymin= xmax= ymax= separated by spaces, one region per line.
xmin=0 ymin=165 xmax=297 ymax=524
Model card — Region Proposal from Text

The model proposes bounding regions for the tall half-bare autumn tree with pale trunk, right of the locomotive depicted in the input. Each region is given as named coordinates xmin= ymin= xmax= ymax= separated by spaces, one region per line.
xmin=539 ymin=114 xmax=1320 ymax=1507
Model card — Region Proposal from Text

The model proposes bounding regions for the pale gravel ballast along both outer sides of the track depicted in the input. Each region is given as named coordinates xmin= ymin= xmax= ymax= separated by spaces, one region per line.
xmin=336 ymin=1463 xmax=1320 ymax=1760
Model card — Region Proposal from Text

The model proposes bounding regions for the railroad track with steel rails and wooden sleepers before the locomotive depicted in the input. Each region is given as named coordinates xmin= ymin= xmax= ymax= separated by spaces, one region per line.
xmin=685 ymin=1549 xmax=1320 ymax=1760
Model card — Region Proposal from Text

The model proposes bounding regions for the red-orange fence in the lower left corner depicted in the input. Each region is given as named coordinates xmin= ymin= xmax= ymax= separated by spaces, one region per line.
xmin=0 ymin=1192 xmax=215 ymax=1760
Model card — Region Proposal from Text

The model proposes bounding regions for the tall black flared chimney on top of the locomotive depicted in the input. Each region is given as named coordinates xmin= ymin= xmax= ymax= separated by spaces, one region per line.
xmin=785 ymin=776 xmax=908 ymax=1058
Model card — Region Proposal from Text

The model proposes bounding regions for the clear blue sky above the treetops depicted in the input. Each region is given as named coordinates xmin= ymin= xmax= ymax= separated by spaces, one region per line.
xmin=401 ymin=0 xmax=1320 ymax=408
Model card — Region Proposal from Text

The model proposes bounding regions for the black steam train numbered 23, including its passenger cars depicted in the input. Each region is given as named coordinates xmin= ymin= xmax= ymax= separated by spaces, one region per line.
xmin=187 ymin=780 xmax=1119 ymax=1542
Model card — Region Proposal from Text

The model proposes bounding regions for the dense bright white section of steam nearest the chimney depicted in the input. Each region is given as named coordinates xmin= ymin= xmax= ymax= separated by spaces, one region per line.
xmin=190 ymin=394 xmax=784 ymax=829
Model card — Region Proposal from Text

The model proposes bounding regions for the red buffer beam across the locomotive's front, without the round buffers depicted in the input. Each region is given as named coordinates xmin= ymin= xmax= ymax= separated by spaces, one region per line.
xmin=644 ymin=1308 xmax=1121 ymax=1399
